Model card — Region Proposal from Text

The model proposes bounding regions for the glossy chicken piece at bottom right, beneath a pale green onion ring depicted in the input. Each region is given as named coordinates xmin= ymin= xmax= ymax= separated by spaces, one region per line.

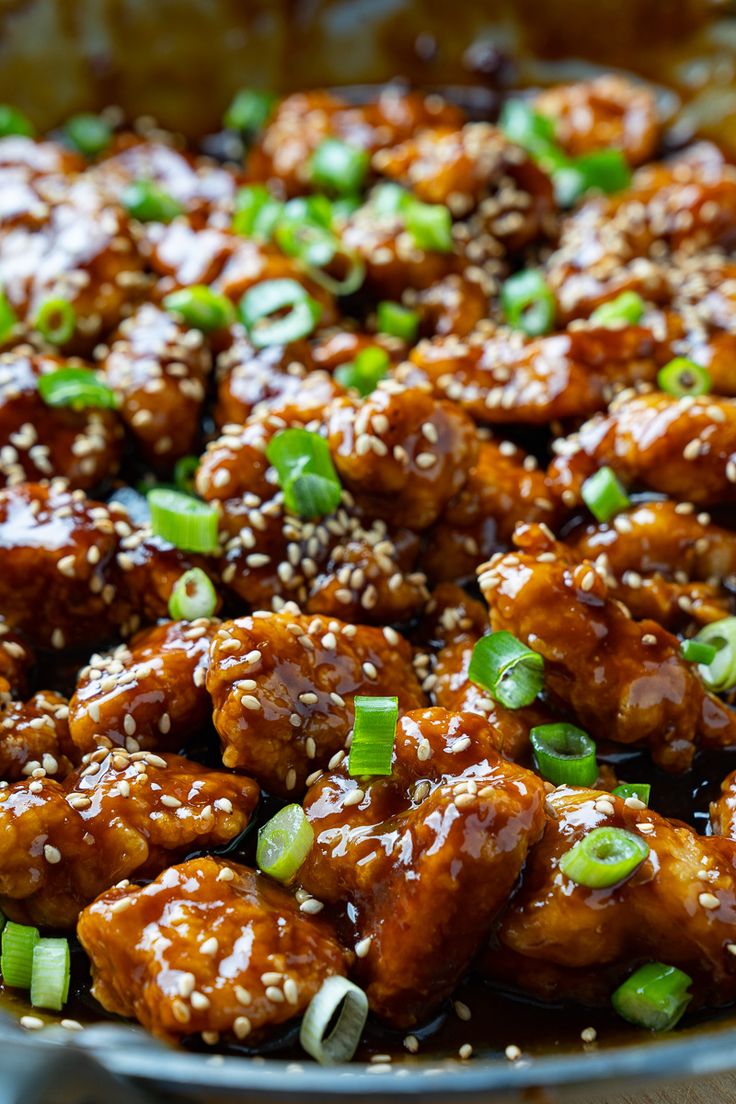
xmin=483 ymin=786 xmax=736 ymax=1004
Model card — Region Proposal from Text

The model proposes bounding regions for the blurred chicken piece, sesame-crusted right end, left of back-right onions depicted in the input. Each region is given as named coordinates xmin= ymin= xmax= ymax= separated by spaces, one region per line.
xmin=373 ymin=123 xmax=554 ymax=246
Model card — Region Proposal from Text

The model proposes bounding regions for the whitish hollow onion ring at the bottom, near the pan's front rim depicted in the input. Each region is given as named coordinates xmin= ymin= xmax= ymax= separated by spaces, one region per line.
xmin=299 ymin=974 xmax=369 ymax=1065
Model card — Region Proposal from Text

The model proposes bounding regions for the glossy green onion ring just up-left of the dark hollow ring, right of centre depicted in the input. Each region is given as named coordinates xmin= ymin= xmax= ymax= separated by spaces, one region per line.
xmin=468 ymin=631 xmax=544 ymax=709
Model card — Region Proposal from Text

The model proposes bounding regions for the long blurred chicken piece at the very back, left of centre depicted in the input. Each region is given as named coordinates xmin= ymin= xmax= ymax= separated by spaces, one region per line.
xmin=247 ymin=88 xmax=462 ymax=195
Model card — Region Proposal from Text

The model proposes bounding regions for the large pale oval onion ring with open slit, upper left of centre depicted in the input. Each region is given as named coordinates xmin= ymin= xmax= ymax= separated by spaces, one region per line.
xmin=237 ymin=279 xmax=322 ymax=349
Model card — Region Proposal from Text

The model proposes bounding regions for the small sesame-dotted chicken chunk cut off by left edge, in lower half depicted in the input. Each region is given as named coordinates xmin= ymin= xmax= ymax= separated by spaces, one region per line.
xmin=0 ymin=690 xmax=79 ymax=782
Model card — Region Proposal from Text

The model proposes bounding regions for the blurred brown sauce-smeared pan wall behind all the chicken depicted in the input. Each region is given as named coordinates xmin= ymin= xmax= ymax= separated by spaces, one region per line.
xmin=0 ymin=0 xmax=736 ymax=147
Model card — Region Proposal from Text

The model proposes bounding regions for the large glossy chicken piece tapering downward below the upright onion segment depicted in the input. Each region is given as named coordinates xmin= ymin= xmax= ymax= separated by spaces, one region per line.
xmin=299 ymin=709 xmax=544 ymax=1028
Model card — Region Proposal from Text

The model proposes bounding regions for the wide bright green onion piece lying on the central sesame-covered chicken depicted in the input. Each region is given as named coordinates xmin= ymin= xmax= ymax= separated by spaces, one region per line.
xmin=266 ymin=428 xmax=342 ymax=518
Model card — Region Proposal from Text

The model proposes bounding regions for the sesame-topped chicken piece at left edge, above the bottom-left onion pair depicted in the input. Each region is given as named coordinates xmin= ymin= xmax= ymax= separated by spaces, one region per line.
xmin=0 ymin=747 xmax=258 ymax=927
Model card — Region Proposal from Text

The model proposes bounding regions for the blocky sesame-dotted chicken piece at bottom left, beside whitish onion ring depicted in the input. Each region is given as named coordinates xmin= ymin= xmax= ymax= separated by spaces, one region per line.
xmin=77 ymin=858 xmax=348 ymax=1042
